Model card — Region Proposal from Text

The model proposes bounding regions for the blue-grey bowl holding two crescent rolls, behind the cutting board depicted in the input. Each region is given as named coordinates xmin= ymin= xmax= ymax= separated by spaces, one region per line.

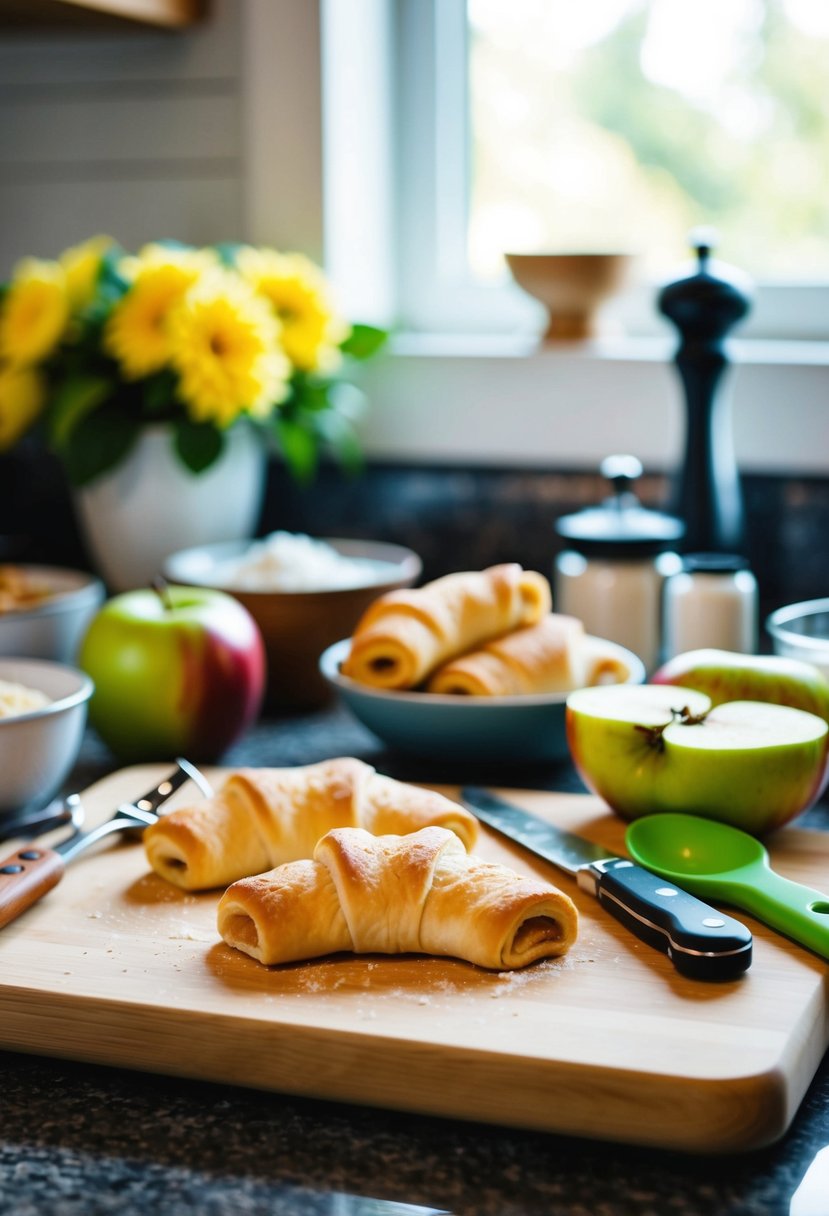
xmin=320 ymin=638 xmax=645 ymax=764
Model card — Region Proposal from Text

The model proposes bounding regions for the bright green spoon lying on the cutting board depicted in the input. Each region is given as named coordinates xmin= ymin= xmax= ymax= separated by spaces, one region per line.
xmin=625 ymin=812 xmax=829 ymax=958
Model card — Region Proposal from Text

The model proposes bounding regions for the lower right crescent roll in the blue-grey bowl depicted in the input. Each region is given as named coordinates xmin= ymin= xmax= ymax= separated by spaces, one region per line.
xmin=427 ymin=613 xmax=630 ymax=697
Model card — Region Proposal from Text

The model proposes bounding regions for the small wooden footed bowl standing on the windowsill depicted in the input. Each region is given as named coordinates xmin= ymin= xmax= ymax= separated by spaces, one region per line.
xmin=504 ymin=253 xmax=635 ymax=342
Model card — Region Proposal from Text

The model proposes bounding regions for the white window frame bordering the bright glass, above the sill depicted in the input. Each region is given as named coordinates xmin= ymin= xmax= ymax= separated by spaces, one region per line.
xmin=396 ymin=0 xmax=829 ymax=340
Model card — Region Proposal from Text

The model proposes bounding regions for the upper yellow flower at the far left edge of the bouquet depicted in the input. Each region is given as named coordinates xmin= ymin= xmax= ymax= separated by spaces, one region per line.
xmin=0 ymin=258 xmax=69 ymax=366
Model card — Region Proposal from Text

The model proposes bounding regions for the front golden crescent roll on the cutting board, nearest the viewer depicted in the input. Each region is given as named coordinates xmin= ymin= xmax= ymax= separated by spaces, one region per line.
xmin=218 ymin=827 xmax=577 ymax=970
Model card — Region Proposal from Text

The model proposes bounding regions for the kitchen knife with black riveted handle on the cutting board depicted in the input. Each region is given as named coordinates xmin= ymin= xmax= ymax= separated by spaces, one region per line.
xmin=461 ymin=786 xmax=752 ymax=980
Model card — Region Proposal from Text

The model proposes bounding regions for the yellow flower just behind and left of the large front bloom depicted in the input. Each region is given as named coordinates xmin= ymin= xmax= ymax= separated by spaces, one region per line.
xmin=103 ymin=244 xmax=216 ymax=379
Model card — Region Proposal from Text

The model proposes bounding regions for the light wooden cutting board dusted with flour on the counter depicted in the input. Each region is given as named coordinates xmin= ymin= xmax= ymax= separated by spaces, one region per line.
xmin=0 ymin=766 xmax=829 ymax=1152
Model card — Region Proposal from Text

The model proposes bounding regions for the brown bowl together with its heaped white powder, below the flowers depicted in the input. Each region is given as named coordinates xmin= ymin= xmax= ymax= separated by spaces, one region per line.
xmin=164 ymin=531 xmax=422 ymax=709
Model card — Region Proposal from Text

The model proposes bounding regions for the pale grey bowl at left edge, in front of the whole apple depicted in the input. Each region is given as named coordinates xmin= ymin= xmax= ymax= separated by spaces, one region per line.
xmin=0 ymin=659 xmax=92 ymax=817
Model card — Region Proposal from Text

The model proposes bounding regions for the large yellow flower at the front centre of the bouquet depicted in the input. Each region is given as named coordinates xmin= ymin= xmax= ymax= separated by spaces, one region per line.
xmin=170 ymin=270 xmax=291 ymax=427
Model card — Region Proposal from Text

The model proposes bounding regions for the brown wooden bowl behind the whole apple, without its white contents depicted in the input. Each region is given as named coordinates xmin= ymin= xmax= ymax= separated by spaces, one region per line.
xmin=164 ymin=536 xmax=422 ymax=710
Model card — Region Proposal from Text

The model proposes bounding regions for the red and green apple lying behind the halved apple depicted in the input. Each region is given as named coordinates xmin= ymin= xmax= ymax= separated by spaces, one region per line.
xmin=650 ymin=649 xmax=829 ymax=722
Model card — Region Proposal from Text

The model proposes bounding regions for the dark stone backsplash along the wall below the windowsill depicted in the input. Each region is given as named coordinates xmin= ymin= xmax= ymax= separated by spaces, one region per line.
xmin=0 ymin=447 xmax=829 ymax=612
